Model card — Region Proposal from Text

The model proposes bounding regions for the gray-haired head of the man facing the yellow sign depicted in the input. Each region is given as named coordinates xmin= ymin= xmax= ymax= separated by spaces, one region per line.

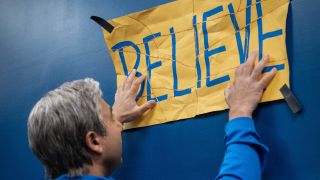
xmin=28 ymin=78 xmax=122 ymax=178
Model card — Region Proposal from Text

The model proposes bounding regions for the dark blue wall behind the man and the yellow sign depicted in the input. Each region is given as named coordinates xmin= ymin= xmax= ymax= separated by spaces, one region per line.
xmin=0 ymin=0 xmax=320 ymax=180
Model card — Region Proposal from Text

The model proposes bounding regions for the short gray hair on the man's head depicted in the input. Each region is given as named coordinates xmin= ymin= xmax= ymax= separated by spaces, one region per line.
xmin=28 ymin=78 xmax=107 ymax=178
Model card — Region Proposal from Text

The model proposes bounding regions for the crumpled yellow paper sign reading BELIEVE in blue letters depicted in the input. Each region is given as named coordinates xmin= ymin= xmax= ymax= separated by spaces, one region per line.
xmin=103 ymin=0 xmax=289 ymax=129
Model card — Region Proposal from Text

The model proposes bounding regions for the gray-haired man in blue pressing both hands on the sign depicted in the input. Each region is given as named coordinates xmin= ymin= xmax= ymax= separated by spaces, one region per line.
xmin=28 ymin=52 xmax=276 ymax=180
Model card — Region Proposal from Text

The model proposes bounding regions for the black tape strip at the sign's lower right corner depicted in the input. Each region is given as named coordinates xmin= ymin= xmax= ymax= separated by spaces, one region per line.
xmin=280 ymin=84 xmax=302 ymax=113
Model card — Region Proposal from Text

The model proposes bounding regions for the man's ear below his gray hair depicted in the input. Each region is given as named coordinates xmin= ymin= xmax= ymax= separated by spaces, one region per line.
xmin=86 ymin=131 xmax=103 ymax=154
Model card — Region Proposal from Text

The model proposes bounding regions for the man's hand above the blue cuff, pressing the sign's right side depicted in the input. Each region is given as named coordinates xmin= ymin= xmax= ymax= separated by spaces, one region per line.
xmin=225 ymin=51 xmax=277 ymax=120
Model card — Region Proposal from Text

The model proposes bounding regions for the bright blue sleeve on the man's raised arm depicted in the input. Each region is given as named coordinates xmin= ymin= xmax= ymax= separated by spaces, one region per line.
xmin=216 ymin=117 xmax=269 ymax=180
